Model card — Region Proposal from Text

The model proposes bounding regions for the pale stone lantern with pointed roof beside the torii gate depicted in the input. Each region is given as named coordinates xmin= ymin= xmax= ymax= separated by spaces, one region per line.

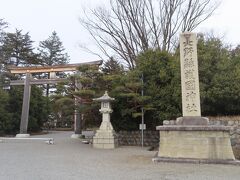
xmin=93 ymin=91 xmax=118 ymax=149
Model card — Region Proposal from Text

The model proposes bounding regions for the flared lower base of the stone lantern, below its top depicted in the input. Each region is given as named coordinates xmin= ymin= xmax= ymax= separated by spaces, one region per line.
xmin=93 ymin=114 xmax=118 ymax=149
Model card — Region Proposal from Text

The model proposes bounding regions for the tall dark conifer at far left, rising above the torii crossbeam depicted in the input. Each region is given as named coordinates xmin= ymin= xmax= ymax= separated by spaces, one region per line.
xmin=0 ymin=29 xmax=38 ymax=91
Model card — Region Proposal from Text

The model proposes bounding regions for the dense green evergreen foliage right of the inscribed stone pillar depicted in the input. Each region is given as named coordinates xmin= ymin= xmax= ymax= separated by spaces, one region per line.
xmin=198 ymin=36 xmax=240 ymax=116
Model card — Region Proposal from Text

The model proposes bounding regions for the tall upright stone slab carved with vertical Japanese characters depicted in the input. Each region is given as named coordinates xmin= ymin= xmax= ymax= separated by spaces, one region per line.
xmin=180 ymin=32 xmax=201 ymax=116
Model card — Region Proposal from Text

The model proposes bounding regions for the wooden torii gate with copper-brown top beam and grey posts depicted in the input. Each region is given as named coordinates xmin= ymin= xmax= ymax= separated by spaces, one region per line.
xmin=9 ymin=61 xmax=102 ymax=137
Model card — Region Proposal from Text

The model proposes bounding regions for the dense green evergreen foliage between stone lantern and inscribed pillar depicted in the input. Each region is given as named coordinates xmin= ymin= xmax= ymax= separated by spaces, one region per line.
xmin=115 ymin=50 xmax=181 ymax=130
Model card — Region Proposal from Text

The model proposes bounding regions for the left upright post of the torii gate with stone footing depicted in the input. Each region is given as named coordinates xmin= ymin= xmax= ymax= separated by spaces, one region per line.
xmin=16 ymin=73 xmax=31 ymax=137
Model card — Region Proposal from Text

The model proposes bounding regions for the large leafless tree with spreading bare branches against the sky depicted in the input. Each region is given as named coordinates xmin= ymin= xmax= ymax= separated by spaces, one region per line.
xmin=80 ymin=0 xmax=219 ymax=69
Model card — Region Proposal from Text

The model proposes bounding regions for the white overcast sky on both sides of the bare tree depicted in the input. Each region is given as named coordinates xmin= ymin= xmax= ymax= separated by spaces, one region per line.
xmin=0 ymin=0 xmax=240 ymax=63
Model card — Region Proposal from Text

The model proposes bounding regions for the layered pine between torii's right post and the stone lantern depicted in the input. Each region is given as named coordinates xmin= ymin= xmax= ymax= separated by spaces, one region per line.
xmin=72 ymin=65 xmax=104 ymax=128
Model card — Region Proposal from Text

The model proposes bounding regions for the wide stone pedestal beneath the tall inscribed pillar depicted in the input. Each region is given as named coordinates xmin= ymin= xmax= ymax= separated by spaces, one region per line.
xmin=154 ymin=123 xmax=235 ymax=164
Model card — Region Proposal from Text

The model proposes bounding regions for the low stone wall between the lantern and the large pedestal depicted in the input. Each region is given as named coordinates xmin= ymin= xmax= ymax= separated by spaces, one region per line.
xmin=118 ymin=131 xmax=159 ymax=147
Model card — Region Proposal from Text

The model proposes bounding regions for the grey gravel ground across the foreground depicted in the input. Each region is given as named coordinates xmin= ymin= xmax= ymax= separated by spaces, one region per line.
xmin=0 ymin=132 xmax=240 ymax=180
